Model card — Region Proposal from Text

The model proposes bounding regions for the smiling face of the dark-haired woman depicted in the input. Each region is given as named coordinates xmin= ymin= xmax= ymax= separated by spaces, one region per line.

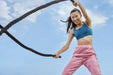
xmin=71 ymin=11 xmax=82 ymax=25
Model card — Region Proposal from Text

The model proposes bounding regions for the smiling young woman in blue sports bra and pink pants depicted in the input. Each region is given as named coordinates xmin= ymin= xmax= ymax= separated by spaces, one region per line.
xmin=54 ymin=1 xmax=101 ymax=75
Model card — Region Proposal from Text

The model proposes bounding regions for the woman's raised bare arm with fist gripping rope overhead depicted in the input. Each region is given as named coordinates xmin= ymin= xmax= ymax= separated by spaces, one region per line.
xmin=73 ymin=1 xmax=91 ymax=26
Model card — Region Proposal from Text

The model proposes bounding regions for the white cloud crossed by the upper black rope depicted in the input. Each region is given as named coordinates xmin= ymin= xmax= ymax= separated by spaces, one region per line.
xmin=12 ymin=0 xmax=44 ymax=22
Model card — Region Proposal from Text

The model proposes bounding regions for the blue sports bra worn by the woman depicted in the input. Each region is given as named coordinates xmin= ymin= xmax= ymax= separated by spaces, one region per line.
xmin=73 ymin=23 xmax=93 ymax=40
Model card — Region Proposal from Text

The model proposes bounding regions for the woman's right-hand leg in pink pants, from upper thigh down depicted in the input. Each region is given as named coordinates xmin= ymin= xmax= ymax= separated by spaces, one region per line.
xmin=84 ymin=55 xmax=101 ymax=75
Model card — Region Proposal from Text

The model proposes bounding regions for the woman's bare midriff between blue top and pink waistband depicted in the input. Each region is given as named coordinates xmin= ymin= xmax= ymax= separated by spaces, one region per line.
xmin=78 ymin=35 xmax=93 ymax=45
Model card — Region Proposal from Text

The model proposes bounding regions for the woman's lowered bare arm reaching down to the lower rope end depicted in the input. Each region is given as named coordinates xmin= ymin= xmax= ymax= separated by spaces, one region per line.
xmin=54 ymin=29 xmax=74 ymax=58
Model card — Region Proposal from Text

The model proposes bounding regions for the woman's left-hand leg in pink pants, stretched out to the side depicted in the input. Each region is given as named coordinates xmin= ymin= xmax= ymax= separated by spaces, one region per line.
xmin=62 ymin=57 xmax=83 ymax=75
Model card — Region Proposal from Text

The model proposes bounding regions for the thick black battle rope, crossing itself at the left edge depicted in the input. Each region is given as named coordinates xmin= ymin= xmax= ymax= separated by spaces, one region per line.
xmin=0 ymin=0 xmax=74 ymax=58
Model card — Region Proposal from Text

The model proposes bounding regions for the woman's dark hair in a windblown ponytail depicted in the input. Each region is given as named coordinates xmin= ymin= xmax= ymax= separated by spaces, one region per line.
xmin=62 ymin=8 xmax=81 ymax=33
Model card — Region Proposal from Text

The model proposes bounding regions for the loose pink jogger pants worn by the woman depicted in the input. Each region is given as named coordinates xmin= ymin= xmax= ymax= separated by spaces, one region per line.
xmin=62 ymin=45 xmax=101 ymax=75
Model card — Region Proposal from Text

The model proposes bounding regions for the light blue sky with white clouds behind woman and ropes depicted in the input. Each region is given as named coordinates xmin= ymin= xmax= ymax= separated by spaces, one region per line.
xmin=0 ymin=0 xmax=113 ymax=75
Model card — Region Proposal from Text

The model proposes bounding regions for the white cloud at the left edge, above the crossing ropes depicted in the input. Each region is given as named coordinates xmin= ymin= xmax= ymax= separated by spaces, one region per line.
xmin=0 ymin=0 xmax=11 ymax=20
